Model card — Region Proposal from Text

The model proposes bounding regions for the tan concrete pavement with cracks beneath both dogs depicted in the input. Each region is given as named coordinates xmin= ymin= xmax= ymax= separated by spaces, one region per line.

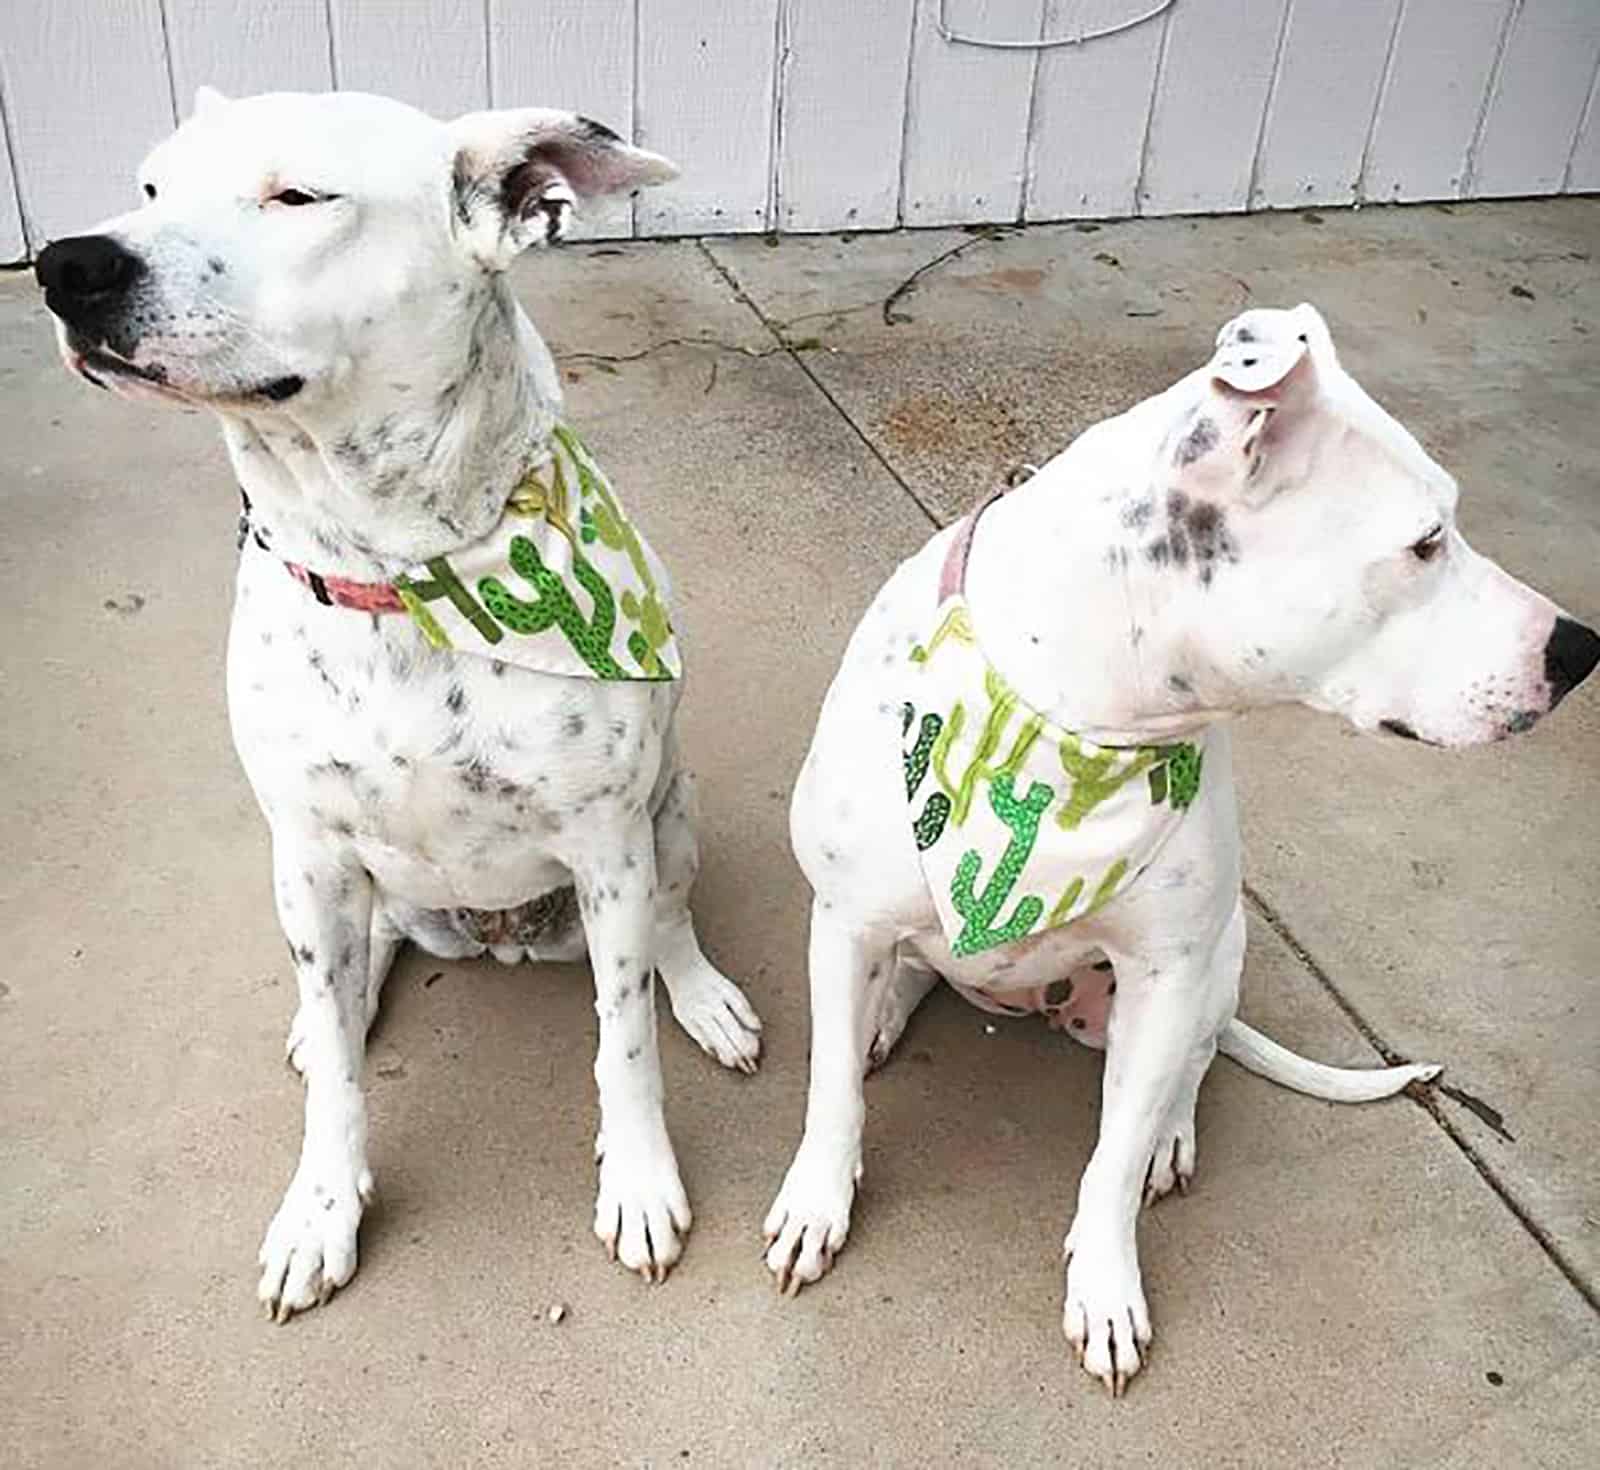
xmin=0 ymin=200 xmax=1600 ymax=1467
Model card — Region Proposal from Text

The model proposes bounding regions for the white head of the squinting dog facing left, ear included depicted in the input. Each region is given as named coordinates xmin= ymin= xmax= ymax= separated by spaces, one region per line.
xmin=37 ymin=88 xmax=675 ymax=409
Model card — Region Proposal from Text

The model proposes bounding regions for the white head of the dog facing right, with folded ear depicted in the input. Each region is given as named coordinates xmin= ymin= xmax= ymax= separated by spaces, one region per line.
xmin=1146 ymin=306 xmax=1600 ymax=745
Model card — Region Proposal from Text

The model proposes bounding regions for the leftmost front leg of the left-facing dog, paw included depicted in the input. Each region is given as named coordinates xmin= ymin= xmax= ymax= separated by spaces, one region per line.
xmin=258 ymin=840 xmax=373 ymax=1321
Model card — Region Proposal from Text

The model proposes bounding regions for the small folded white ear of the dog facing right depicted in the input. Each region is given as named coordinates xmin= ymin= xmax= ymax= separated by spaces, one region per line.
xmin=1173 ymin=302 xmax=1334 ymax=491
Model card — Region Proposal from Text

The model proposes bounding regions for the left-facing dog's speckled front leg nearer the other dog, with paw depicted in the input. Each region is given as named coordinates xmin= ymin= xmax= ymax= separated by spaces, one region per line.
xmin=573 ymin=811 xmax=691 ymax=1281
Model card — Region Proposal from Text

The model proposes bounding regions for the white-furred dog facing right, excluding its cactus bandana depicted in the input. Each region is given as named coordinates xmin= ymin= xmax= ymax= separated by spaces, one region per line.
xmin=766 ymin=306 xmax=1592 ymax=1393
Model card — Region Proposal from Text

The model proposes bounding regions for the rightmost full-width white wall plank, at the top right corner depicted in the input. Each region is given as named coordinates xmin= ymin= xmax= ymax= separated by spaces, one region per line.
xmin=1467 ymin=0 xmax=1600 ymax=198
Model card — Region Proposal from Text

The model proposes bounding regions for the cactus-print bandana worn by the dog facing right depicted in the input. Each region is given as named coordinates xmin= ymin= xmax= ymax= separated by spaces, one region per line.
xmin=901 ymin=598 xmax=1205 ymax=955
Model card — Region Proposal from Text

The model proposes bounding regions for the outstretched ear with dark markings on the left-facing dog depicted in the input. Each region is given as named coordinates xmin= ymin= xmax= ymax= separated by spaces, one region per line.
xmin=450 ymin=107 xmax=678 ymax=269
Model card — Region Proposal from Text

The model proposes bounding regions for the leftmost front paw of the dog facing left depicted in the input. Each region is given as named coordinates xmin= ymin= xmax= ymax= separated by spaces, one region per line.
xmin=256 ymin=1164 xmax=373 ymax=1321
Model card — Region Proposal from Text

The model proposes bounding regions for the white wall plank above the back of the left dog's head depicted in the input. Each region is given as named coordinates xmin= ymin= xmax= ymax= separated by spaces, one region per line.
xmin=328 ymin=0 xmax=490 ymax=117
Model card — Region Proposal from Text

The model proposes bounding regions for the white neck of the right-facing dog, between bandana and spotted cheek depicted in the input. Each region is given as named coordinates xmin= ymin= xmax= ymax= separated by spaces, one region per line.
xmin=966 ymin=441 xmax=1238 ymax=745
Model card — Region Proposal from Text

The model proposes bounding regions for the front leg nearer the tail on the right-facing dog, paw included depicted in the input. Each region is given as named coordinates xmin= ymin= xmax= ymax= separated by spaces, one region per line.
xmin=1062 ymin=905 xmax=1245 ymax=1395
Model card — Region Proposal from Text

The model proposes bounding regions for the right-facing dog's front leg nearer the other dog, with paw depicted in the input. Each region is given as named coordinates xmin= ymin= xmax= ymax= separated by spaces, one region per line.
xmin=763 ymin=899 xmax=894 ymax=1296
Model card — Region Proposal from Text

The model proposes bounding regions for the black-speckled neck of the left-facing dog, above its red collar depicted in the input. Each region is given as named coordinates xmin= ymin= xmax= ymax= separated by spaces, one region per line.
xmin=221 ymin=277 xmax=560 ymax=581
